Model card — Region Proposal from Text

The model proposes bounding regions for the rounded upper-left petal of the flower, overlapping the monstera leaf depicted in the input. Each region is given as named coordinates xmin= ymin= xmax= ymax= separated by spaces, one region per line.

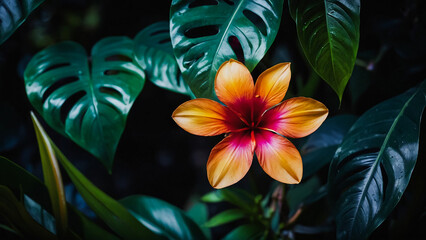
xmin=215 ymin=59 xmax=254 ymax=110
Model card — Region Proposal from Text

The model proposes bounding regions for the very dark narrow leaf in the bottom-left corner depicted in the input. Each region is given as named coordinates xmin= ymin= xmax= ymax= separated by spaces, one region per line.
xmin=0 ymin=185 xmax=57 ymax=239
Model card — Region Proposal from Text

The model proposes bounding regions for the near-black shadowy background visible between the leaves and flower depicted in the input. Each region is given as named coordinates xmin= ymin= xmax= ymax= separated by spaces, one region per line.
xmin=0 ymin=0 xmax=426 ymax=239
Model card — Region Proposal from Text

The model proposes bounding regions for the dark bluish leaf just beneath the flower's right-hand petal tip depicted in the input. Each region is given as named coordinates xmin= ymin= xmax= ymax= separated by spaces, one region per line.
xmin=301 ymin=114 xmax=357 ymax=179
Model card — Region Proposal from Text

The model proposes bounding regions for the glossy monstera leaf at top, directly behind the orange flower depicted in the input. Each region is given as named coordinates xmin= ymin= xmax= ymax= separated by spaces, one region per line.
xmin=170 ymin=0 xmax=283 ymax=98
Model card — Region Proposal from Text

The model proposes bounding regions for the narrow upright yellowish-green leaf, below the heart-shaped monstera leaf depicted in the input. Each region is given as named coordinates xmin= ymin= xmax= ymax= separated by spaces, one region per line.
xmin=31 ymin=112 xmax=68 ymax=236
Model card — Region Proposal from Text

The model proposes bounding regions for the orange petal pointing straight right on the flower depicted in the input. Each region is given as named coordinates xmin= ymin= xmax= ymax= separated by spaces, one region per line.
xmin=259 ymin=97 xmax=328 ymax=138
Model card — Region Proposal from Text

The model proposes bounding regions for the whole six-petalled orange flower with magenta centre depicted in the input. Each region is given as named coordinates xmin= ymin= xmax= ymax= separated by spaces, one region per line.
xmin=172 ymin=59 xmax=328 ymax=188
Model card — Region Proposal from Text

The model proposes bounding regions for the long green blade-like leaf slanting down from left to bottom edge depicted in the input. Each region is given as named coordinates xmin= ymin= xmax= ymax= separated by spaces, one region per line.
xmin=29 ymin=115 xmax=158 ymax=239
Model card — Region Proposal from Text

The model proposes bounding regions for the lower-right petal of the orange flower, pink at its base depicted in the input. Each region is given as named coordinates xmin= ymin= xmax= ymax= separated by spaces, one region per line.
xmin=255 ymin=130 xmax=303 ymax=184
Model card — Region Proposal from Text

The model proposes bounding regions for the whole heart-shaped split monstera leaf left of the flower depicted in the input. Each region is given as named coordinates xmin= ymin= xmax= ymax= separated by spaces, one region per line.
xmin=24 ymin=37 xmax=145 ymax=170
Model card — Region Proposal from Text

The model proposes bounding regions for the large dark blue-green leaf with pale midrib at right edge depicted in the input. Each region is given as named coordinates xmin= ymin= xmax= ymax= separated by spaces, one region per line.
xmin=328 ymin=81 xmax=426 ymax=239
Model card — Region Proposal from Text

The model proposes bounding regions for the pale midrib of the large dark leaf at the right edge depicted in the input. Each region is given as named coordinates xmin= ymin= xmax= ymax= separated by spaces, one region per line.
xmin=349 ymin=88 xmax=420 ymax=236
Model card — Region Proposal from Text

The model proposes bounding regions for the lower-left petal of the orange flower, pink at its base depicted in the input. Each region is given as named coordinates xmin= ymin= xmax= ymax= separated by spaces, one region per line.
xmin=207 ymin=131 xmax=255 ymax=188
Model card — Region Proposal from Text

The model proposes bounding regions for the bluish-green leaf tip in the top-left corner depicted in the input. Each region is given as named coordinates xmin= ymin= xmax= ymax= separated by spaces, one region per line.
xmin=0 ymin=0 xmax=44 ymax=44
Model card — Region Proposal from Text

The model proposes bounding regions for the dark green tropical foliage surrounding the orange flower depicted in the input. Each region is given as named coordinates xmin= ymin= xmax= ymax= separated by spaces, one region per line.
xmin=0 ymin=0 xmax=426 ymax=240
